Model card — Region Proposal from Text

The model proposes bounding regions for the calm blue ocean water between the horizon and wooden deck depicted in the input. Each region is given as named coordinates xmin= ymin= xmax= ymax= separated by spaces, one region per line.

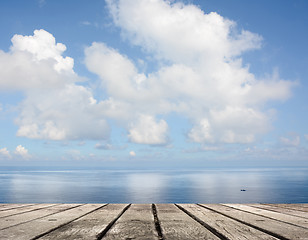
xmin=0 ymin=169 xmax=308 ymax=203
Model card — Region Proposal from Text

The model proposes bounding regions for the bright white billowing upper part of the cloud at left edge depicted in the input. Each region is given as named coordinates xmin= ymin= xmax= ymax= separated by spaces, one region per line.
xmin=0 ymin=29 xmax=82 ymax=91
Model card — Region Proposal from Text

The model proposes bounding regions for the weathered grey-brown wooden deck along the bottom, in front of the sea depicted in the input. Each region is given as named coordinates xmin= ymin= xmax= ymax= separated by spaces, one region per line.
xmin=0 ymin=204 xmax=308 ymax=240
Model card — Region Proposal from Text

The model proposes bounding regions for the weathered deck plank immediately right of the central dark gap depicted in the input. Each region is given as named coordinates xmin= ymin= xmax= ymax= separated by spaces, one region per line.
xmin=156 ymin=204 xmax=219 ymax=240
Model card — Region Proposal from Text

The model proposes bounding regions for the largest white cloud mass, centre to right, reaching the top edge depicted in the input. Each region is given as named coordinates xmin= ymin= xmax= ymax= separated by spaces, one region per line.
xmin=85 ymin=0 xmax=295 ymax=144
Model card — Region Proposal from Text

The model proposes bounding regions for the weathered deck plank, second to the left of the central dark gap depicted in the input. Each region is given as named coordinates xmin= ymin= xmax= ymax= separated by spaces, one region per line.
xmin=40 ymin=204 xmax=127 ymax=240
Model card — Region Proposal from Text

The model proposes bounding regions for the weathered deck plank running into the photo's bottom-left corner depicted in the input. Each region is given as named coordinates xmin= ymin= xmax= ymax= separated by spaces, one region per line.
xmin=0 ymin=204 xmax=102 ymax=240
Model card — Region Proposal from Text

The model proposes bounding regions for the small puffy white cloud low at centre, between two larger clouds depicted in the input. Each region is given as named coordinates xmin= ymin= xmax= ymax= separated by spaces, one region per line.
xmin=128 ymin=115 xmax=168 ymax=144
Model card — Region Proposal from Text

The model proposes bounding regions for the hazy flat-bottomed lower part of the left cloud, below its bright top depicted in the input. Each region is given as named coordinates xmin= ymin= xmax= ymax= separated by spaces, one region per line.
xmin=16 ymin=84 xmax=109 ymax=140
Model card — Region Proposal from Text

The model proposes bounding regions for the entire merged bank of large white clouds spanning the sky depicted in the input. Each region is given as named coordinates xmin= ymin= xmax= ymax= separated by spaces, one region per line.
xmin=0 ymin=0 xmax=295 ymax=148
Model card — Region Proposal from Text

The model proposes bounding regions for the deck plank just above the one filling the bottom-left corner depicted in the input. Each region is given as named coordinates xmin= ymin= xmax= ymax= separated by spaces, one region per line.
xmin=0 ymin=204 xmax=80 ymax=230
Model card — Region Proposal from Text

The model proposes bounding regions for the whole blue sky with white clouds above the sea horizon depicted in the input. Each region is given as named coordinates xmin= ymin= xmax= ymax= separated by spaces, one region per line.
xmin=0 ymin=0 xmax=308 ymax=168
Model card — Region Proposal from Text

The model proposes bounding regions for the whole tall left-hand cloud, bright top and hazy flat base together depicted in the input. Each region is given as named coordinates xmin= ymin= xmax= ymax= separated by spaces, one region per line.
xmin=0 ymin=30 xmax=109 ymax=140
